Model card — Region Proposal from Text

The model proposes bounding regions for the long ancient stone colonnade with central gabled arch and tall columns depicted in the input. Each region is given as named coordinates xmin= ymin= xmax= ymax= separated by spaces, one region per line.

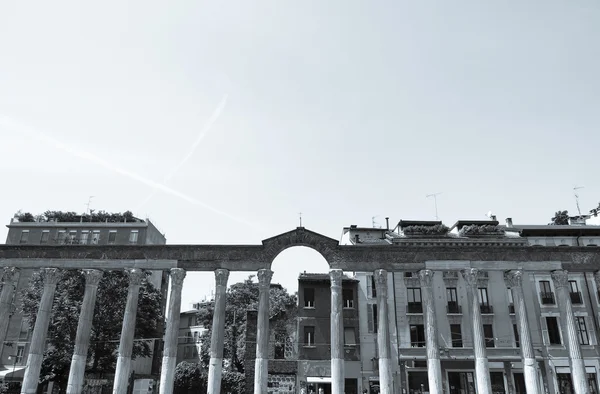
xmin=0 ymin=227 xmax=600 ymax=394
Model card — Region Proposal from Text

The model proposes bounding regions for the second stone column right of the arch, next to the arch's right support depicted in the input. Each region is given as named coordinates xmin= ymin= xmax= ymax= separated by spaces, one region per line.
xmin=373 ymin=270 xmax=394 ymax=394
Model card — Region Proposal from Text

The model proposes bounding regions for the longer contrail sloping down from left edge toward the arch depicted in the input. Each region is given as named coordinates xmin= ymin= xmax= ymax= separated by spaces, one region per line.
xmin=0 ymin=114 xmax=258 ymax=229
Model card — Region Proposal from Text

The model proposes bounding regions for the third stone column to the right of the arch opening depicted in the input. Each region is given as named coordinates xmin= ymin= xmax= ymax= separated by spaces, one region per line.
xmin=419 ymin=270 xmax=443 ymax=394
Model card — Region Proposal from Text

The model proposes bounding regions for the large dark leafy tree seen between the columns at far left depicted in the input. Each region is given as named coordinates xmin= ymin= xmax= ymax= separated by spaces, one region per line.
xmin=22 ymin=270 xmax=162 ymax=393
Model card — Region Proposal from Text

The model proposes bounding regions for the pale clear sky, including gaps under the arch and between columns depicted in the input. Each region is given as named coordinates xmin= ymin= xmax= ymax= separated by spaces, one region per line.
xmin=0 ymin=0 xmax=600 ymax=309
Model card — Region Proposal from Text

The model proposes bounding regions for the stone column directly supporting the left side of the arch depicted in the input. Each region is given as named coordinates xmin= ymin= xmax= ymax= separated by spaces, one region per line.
xmin=254 ymin=269 xmax=273 ymax=393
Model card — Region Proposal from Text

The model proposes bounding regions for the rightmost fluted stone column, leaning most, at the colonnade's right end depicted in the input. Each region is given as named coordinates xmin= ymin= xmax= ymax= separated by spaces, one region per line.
xmin=552 ymin=270 xmax=587 ymax=394
